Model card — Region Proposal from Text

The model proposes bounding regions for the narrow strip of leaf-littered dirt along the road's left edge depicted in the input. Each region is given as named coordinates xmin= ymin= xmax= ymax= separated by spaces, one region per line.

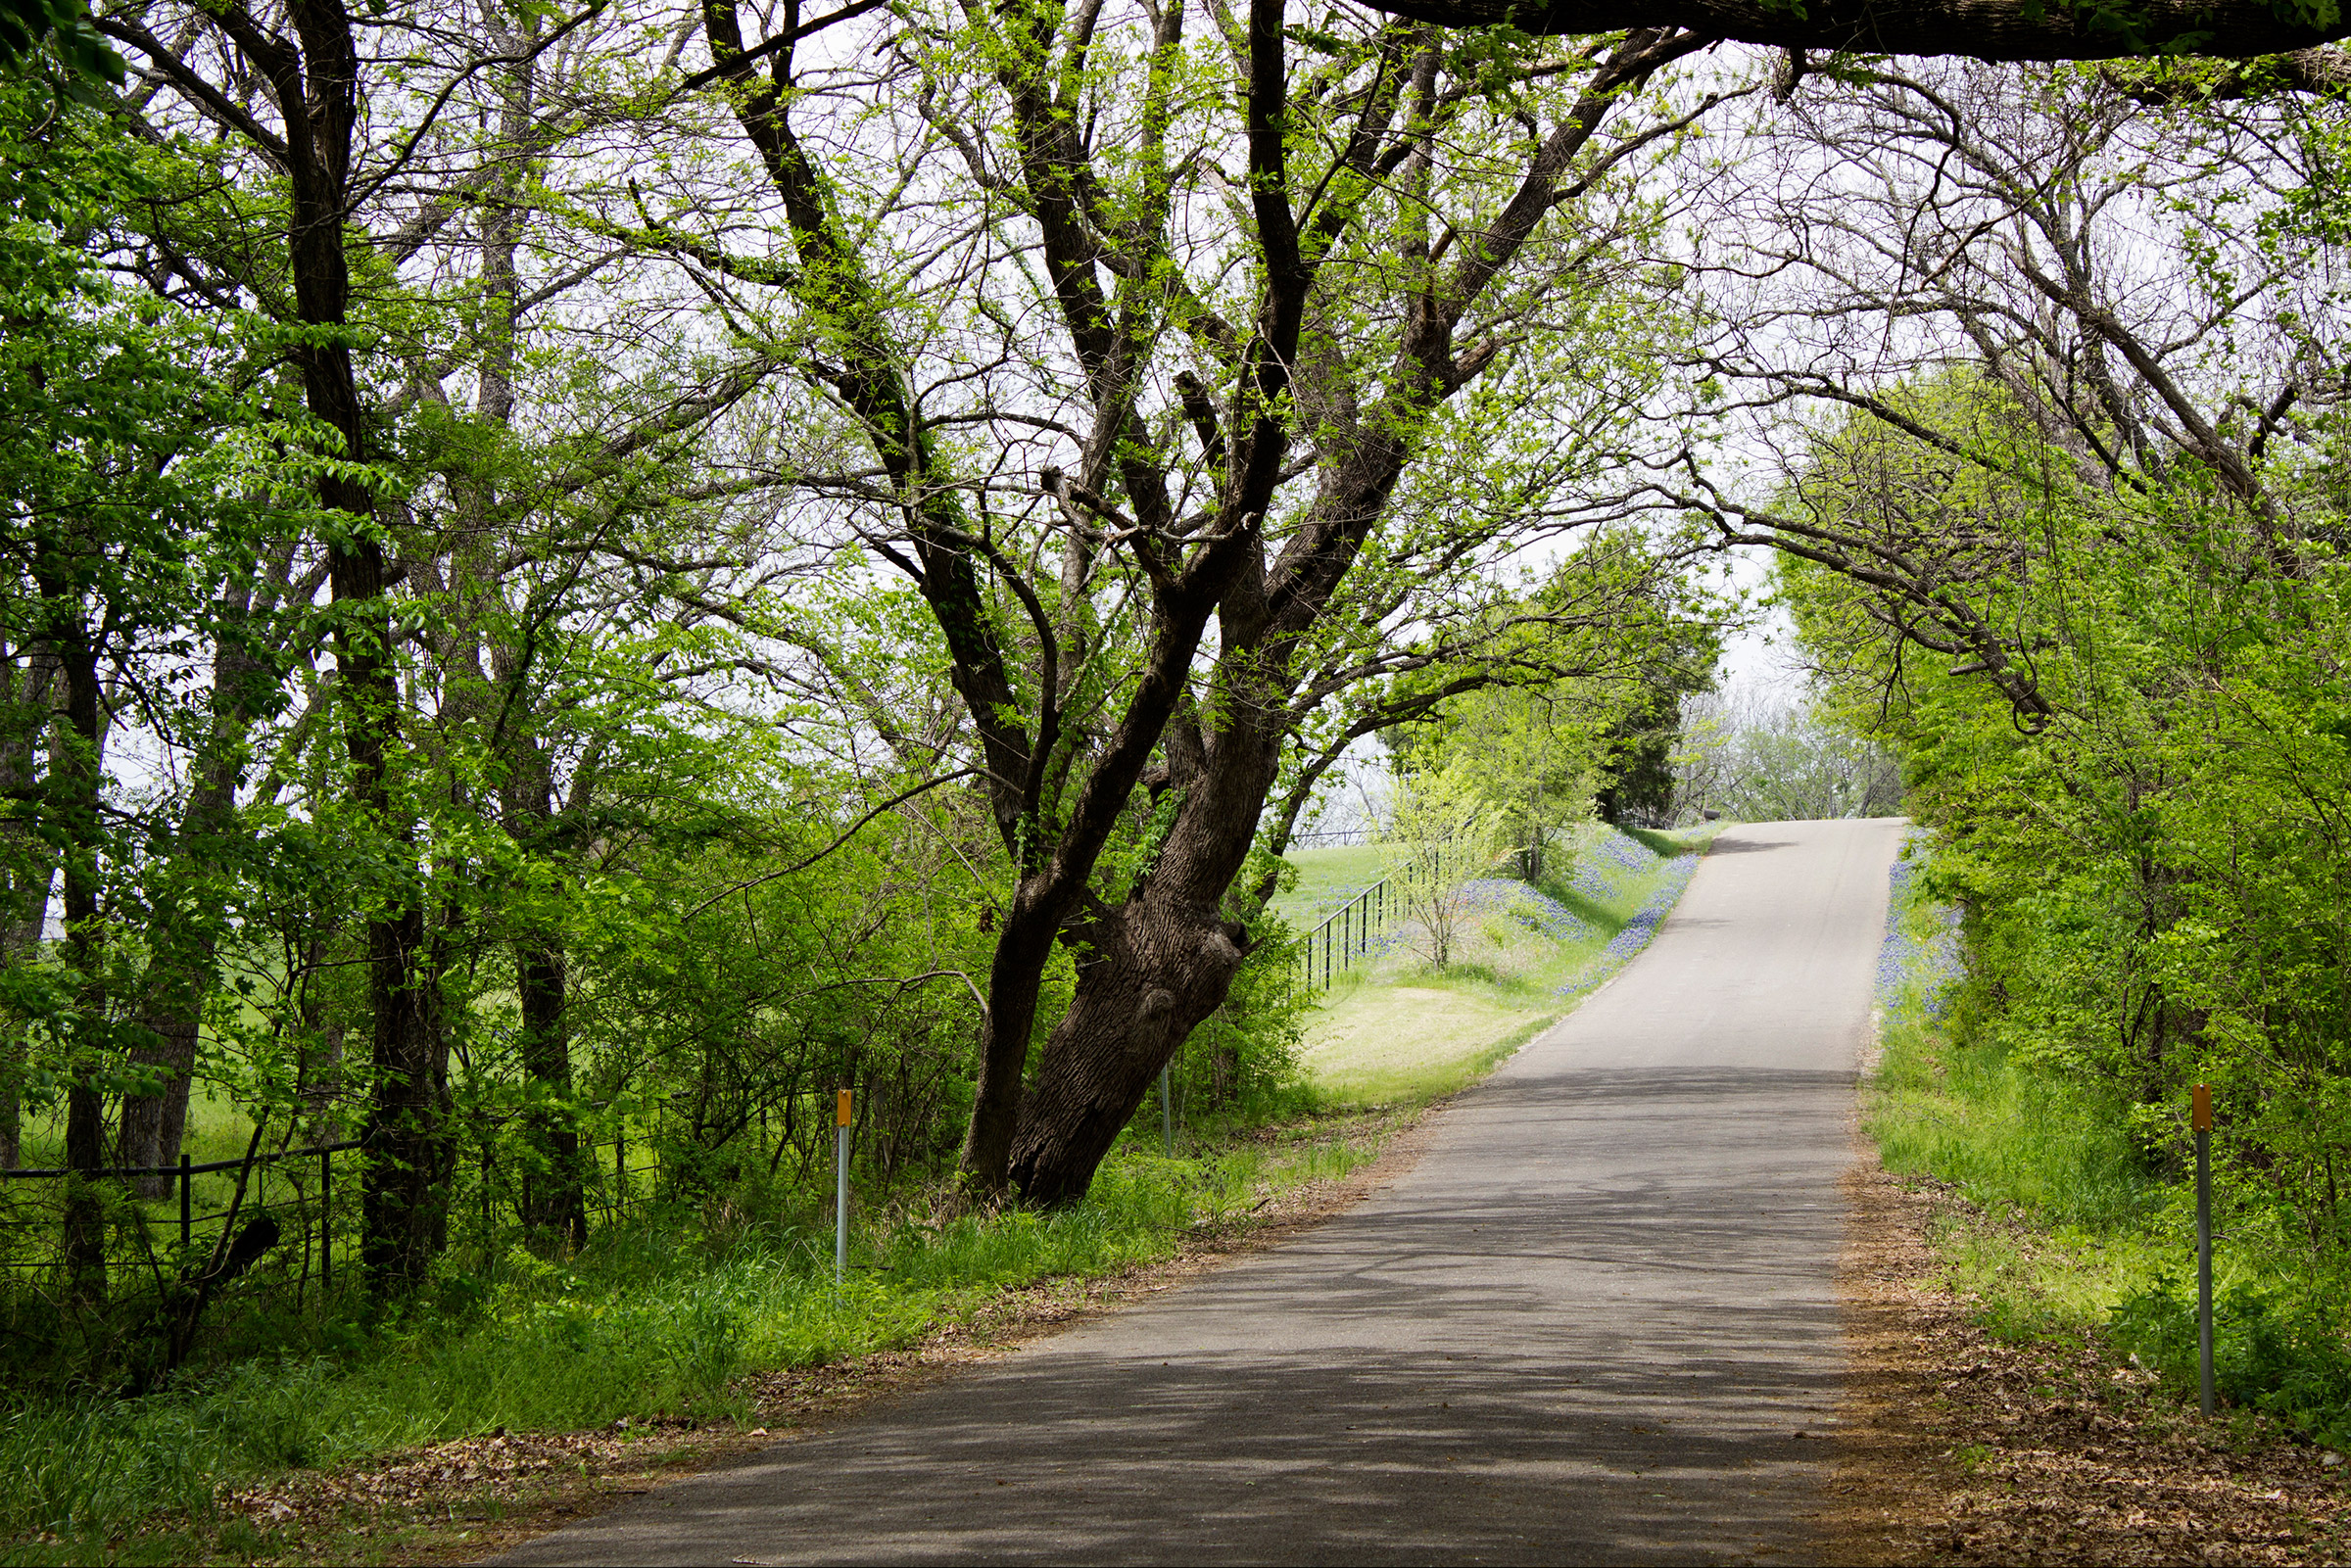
xmin=218 ymin=1105 xmax=1436 ymax=1566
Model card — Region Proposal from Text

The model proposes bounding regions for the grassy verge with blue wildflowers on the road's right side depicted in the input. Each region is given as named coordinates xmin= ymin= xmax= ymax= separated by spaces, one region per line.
xmin=1864 ymin=863 xmax=2351 ymax=1449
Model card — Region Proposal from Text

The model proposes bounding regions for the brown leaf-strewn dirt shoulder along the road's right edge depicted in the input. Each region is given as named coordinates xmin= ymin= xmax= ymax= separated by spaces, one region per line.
xmin=1822 ymin=1157 xmax=2351 ymax=1563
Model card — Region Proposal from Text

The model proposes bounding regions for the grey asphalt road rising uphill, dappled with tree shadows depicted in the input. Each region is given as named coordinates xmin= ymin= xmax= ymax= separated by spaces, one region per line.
xmin=504 ymin=821 xmax=1902 ymax=1563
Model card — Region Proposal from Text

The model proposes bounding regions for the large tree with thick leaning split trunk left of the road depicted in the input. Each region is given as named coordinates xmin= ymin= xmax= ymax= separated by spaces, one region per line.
xmin=672 ymin=0 xmax=1740 ymax=1202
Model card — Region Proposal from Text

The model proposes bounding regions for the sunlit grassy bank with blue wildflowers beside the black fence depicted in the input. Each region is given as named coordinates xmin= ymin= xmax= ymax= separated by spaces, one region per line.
xmin=1279 ymin=828 xmax=1714 ymax=1108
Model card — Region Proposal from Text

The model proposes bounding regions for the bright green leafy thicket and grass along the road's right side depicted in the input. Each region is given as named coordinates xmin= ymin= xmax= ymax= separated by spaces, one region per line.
xmin=1824 ymin=378 xmax=2351 ymax=1432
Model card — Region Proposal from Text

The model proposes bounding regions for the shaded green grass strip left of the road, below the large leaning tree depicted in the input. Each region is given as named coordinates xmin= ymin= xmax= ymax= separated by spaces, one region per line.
xmin=0 ymin=1121 xmax=1389 ymax=1563
